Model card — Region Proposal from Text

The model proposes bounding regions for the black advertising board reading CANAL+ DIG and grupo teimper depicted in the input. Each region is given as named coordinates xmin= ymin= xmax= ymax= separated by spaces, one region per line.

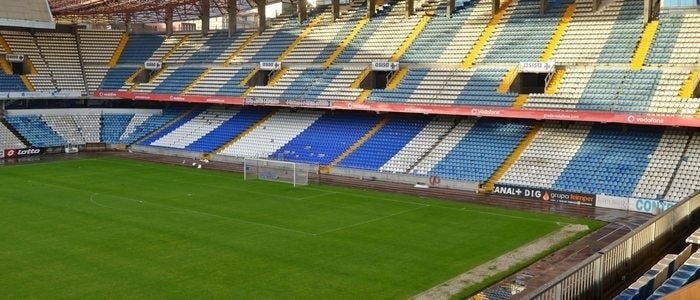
xmin=493 ymin=184 xmax=596 ymax=206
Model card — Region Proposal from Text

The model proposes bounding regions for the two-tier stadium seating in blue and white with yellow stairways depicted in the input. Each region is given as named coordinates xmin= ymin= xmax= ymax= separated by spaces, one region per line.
xmin=0 ymin=0 xmax=700 ymax=299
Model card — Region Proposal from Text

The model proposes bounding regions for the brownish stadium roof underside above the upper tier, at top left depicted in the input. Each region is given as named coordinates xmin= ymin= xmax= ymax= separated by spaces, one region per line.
xmin=48 ymin=0 xmax=257 ymax=23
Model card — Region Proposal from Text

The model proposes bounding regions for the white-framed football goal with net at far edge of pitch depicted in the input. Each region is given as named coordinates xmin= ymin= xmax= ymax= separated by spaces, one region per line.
xmin=243 ymin=158 xmax=309 ymax=186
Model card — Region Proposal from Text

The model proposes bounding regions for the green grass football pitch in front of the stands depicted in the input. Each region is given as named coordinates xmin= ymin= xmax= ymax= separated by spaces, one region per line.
xmin=0 ymin=157 xmax=601 ymax=299
